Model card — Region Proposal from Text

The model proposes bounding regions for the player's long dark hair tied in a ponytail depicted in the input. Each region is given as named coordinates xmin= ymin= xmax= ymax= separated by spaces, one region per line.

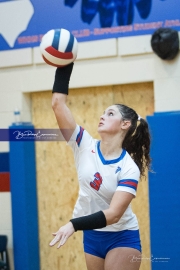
xmin=115 ymin=104 xmax=151 ymax=176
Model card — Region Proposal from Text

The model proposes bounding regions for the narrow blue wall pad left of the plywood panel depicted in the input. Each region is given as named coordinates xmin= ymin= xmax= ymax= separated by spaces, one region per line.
xmin=10 ymin=123 xmax=40 ymax=270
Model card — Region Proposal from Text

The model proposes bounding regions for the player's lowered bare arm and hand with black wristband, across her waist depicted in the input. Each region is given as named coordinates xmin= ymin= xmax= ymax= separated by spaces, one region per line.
xmin=49 ymin=191 xmax=134 ymax=248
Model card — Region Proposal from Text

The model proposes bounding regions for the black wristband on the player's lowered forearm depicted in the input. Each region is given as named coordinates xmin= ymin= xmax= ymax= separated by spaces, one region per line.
xmin=70 ymin=211 xmax=106 ymax=231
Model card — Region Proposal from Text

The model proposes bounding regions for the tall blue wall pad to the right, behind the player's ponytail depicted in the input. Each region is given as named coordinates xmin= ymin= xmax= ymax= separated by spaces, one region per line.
xmin=147 ymin=112 xmax=180 ymax=270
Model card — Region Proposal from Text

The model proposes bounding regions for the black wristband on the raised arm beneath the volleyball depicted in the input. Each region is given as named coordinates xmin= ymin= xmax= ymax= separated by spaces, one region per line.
xmin=52 ymin=63 xmax=74 ymax=95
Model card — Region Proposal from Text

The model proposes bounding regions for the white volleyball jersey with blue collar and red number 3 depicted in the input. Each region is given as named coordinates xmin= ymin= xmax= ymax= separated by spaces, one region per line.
xmin=68 ymin=125 xmax=140 ymax=231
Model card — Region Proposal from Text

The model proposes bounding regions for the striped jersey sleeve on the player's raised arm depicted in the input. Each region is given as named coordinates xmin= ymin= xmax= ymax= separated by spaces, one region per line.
xmin=67 ymin=125 xmax=93 ymax=151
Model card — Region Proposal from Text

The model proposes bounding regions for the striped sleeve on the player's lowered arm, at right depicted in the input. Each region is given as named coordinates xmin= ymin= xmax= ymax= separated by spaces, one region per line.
xmin=116 ymin=164 xmax=140 ymax=197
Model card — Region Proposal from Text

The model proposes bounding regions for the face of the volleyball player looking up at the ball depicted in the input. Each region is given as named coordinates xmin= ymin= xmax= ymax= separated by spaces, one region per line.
xmin=98 ymin=105 xmax=122 ymax=134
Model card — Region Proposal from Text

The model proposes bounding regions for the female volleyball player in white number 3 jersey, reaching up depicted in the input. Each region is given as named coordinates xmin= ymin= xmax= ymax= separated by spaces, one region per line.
xmin=50 ymin=63 xmax=150 ymax=270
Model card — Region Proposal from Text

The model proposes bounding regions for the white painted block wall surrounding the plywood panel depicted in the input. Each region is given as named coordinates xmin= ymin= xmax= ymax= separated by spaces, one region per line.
xmin=0 ymin=35 xmax=180 ymax=268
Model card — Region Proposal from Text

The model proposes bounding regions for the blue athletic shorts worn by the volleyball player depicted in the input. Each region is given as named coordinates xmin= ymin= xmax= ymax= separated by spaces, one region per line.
xmin=83 ymin=230 xmax=141 ymax=259
